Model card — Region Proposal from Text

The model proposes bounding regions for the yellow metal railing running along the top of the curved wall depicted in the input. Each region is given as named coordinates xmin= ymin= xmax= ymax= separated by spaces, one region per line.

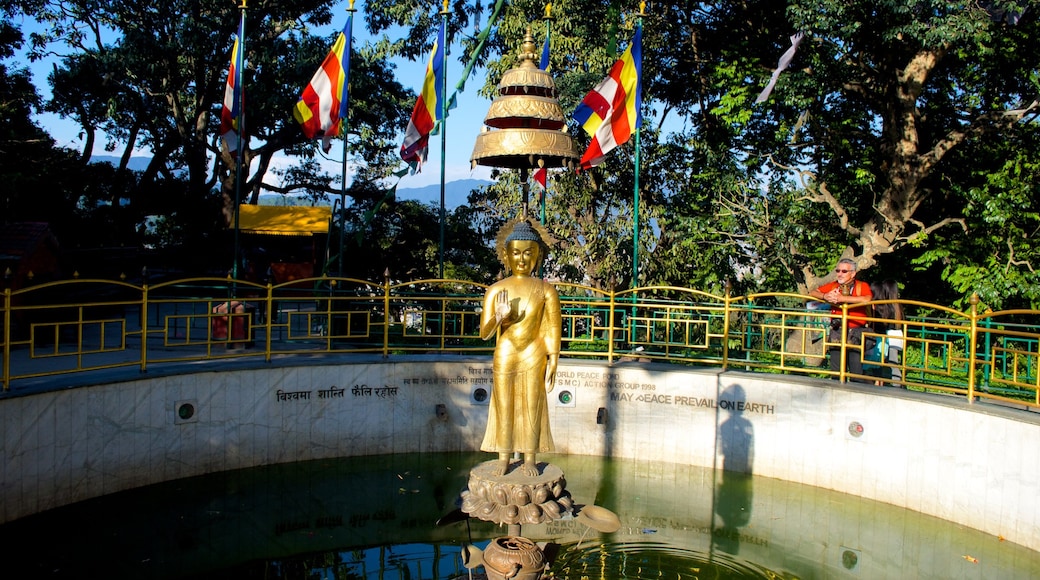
xmin=0 ymin=278 xmax=1040 ymax=406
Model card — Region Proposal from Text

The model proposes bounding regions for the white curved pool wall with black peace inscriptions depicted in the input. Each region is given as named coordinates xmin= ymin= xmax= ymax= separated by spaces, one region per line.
xmin=0 ymin=357 xmax=1040 ymax=550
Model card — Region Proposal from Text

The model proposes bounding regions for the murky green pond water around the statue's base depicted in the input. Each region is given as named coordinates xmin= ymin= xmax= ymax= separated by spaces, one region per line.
xmin=0 ymin=453 xmax=1040 ymax=580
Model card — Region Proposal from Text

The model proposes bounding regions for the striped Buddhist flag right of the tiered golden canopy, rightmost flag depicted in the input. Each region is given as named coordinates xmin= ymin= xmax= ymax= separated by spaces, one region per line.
xmin=574 ymin=25 xmax=643 ymax=169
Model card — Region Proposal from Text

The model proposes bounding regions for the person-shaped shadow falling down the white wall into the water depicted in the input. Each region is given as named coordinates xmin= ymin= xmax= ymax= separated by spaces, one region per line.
xmin=711 ymin=385 xmax=755 ymax=555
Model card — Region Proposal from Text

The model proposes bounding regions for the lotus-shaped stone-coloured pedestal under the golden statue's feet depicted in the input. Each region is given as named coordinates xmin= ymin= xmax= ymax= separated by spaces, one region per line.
xmin=462 ymin=460 xmax=574 ymax=526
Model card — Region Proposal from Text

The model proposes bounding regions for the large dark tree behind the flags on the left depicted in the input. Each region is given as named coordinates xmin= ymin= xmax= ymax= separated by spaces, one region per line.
xmin=22 ymin=0 xmax=409 ymax=252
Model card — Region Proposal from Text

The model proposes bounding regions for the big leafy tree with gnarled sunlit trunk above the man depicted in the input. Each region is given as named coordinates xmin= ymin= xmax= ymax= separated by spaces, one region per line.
xmin=720 ymin=0 xmax=1040 ymax=299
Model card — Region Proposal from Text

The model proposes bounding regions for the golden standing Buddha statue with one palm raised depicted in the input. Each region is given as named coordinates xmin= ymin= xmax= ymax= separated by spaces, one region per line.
xmin=480 ymin=219 xmax=562 ymax=477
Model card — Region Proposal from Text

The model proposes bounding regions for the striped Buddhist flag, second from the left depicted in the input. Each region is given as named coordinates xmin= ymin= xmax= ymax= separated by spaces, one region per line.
xmin=292 ymin=14 xmax=354 ymax=153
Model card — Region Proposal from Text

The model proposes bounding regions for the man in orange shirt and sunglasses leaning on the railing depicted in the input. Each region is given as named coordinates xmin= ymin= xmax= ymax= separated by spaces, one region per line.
xmin=809 ymin=258 xmax=874 ymax=380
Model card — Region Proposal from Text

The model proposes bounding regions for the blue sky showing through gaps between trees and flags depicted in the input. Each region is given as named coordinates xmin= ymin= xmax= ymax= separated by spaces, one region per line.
xmin=15 ymin=0 xmax=499 ymax=188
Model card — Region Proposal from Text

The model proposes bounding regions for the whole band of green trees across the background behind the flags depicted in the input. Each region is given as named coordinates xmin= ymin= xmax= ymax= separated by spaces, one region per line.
xmin=0 ymin=0 xmax=1040 ymax=308
